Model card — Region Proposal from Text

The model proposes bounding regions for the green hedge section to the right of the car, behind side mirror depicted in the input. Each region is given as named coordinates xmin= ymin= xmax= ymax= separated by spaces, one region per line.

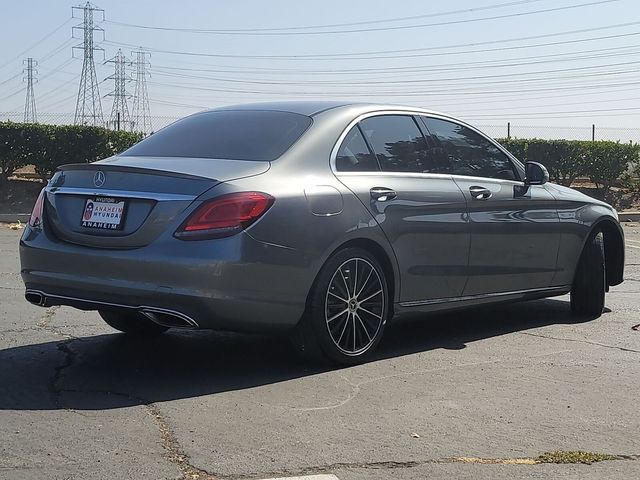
xmin=499 ymin=138 xmax=640 ymax=193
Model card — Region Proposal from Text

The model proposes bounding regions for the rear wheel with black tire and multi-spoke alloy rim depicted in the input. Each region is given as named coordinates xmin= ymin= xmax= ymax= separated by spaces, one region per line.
xmin=291 ymin=248 xmax=391 ymax=365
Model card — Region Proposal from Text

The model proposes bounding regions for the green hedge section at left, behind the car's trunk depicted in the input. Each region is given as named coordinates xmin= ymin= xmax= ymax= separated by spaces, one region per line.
xmin=0 ymin=122 xmax=142 ymax=186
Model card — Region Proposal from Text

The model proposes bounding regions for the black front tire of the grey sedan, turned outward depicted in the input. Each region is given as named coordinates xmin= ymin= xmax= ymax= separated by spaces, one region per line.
xmin=571 ymin=232 xmax=607 ymax=318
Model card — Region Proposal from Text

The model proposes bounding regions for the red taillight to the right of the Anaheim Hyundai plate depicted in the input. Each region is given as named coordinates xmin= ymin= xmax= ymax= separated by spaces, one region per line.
xmin=174 ymin=192 xmax=274 ymax=240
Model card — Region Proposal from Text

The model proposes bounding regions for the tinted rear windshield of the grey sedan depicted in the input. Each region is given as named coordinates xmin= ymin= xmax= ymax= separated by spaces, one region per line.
xmin=122 ymin=110 xmax=311 ymax=162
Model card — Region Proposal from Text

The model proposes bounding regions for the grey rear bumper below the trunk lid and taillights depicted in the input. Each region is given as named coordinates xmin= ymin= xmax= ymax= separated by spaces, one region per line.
xmin=20 ymin=227 xmax=313 ymax=332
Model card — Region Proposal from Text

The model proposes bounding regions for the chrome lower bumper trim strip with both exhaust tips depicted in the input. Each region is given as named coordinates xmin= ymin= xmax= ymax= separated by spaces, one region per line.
xmin=24 ymin=290 xmax=199 ymax=328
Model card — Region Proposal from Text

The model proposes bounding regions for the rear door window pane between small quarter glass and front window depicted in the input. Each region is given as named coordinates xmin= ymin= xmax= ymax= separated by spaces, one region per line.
xmin=360 ymin=115 xmax=435 ymax=173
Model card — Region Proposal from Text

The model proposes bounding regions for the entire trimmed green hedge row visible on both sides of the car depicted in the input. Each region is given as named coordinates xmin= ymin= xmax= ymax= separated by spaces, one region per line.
xmin=0 ymin=122 xmax=640 ymax=193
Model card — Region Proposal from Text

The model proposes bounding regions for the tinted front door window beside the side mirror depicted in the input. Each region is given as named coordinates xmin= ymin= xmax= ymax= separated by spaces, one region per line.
xmin=422 ymin=117 xmax=518 ymax=180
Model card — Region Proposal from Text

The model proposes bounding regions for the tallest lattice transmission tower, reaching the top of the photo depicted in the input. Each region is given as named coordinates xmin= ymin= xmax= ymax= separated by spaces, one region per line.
xmin=72 ymin=2 xmax=104 ymax=126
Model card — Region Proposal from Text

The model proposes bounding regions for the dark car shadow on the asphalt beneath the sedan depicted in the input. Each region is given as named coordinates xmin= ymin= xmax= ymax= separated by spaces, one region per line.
xmin=0 ymin=300 xmax=596 ymax=410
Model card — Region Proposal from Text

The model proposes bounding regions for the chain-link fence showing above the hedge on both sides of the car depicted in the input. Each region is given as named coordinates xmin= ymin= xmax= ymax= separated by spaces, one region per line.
xmin=0 ymin=112 xmax=640 ymax=143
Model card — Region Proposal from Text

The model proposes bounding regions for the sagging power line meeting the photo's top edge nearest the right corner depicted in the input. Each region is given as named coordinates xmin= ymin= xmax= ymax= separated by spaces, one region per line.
xmin=102 ymin=0 xmax=620 ymax=36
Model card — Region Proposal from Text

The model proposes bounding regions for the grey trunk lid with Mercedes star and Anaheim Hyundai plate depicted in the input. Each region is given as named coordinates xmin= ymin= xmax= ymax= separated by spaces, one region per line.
xmin=45 ymin=157 xmax=270 ymax=248
